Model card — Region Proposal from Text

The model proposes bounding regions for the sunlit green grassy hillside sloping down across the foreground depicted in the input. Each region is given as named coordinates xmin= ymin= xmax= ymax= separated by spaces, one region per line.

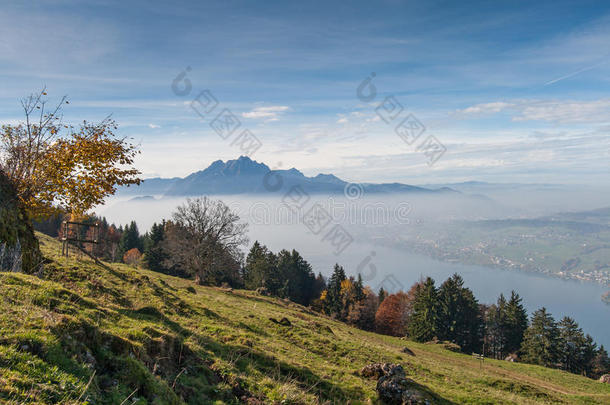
xmin=0 ymin=236 xmax=610 ymax=404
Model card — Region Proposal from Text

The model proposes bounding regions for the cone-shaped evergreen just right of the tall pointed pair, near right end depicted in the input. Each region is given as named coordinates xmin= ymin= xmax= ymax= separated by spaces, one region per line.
xmin=521 ymin=307 xmax=560 ymax=367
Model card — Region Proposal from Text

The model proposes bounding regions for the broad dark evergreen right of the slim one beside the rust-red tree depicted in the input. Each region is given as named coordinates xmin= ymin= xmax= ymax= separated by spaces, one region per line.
xmin=438 ymin=274 xmax=482 ymax=352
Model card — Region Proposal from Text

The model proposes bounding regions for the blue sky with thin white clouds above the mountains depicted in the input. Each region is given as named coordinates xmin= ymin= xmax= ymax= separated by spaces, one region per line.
xmin=0 ymin=1 xmax=610 ymax=185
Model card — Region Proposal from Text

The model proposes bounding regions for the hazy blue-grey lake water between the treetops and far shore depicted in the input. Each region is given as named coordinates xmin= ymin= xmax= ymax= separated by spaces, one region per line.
xmin=250 ymin=225 xmax=610 ymax=348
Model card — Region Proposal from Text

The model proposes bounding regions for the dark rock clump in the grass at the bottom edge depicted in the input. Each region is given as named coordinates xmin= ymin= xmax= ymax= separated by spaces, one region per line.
xmin=360 ymin=363 xmax=433 ymax=405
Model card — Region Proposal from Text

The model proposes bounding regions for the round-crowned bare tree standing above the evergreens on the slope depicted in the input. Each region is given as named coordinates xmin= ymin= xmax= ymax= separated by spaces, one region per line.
xmin=164 ymin=197 xmax=248 ymax=284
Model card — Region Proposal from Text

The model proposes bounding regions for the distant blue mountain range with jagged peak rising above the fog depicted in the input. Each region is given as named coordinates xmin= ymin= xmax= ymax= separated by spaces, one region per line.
xmin=119 ymin=156 xmax=458 ymax=197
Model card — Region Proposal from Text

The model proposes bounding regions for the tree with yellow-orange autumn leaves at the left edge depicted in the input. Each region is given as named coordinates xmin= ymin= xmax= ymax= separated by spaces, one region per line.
xmin=0 ymin=90 xmax=141 ymax=218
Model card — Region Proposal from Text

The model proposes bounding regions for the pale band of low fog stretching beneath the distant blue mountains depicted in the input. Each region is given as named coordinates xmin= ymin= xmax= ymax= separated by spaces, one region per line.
xmin=96 ymin=186 xmax=610 ymax=232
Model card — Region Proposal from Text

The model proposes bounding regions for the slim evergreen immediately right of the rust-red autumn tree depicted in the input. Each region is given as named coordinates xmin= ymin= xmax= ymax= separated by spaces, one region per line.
xmin=407 ymin=277 xmax=439 ymax=342
